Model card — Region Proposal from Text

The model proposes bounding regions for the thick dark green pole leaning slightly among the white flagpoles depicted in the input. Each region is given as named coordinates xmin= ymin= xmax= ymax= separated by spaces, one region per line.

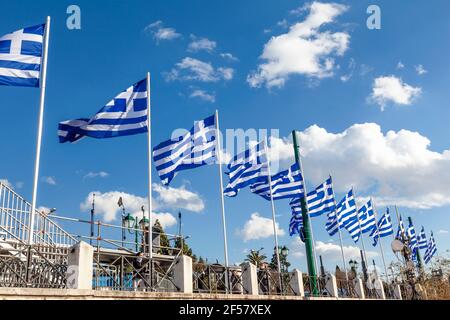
xmin=292 ymin=130 xmax=319 ymax=296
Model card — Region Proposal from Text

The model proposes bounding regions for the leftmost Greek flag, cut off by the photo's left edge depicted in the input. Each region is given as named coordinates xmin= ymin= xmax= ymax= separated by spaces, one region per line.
xmin=0 ymin=24 xmax=45 ymax=87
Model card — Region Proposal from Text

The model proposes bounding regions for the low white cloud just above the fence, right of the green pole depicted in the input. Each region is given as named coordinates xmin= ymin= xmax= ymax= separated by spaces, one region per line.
xmin=291 ymin=238 xmax=378 ymax=262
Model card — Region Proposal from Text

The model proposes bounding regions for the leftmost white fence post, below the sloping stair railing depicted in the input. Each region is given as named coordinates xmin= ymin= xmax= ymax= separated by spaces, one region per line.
xmin=66 ymin=241 xmax=94 ymax=290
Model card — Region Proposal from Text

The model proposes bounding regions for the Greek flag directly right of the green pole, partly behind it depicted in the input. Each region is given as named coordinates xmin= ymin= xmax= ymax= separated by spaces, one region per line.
xmin=289 ymin=177 xmax=335 ymax=217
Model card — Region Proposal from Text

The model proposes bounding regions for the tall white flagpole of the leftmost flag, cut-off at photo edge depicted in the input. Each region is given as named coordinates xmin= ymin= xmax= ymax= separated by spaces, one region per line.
xmin=28 ymin=17 xmax=50 ymax=245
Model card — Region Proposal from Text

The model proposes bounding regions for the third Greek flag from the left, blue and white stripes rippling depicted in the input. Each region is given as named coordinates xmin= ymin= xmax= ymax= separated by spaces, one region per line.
xmin=153 ymin=115 xmax=216 ymax=185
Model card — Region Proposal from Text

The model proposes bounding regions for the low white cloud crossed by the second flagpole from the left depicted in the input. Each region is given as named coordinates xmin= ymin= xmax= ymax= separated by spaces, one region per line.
xmin=80 ymin=191 xmax=177 ymax=228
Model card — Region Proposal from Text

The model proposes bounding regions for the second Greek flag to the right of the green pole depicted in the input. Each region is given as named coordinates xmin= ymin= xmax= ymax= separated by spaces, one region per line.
xmin=326 ymin=189 xmax=359 ymax=242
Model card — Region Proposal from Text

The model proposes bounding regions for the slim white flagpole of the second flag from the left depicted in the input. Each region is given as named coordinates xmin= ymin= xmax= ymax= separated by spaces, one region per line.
xmin=147 ymin=72 xmax=153 ymax=264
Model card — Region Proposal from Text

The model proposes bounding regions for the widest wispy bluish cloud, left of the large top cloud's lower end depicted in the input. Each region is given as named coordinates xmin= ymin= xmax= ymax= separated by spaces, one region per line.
xmin=165 ymin=57 xmax=234 ymax=82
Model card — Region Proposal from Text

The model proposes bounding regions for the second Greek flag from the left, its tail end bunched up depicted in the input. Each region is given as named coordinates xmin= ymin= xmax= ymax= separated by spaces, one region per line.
xmin=58 ymin=79 xmax=147 ymax=143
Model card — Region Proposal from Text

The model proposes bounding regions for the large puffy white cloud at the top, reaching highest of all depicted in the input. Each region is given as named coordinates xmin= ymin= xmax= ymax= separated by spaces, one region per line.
xmin=247 ymin=2 xmax=350 ymax=88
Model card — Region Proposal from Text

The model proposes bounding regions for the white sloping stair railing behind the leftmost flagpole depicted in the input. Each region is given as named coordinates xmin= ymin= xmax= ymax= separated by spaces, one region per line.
xmin=0 ymin=182 xmax=77 ymax=246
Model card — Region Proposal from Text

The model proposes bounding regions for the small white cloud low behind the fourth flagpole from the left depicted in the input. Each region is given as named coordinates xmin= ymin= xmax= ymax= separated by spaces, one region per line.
xmin=237 ymin=212 xmax=285 ymax=242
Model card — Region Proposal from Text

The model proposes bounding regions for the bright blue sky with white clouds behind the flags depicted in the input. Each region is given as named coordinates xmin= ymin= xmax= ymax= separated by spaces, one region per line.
xmin=0 ymin=0 xmax=450 ymax=276
